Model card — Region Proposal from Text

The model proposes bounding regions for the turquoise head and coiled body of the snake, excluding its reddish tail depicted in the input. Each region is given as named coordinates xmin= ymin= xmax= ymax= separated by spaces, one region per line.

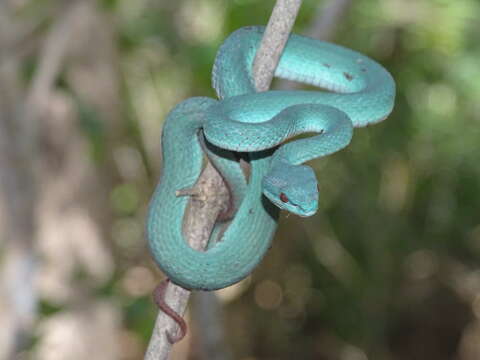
xmin=146 ymin=26 xmax=395 ymax=290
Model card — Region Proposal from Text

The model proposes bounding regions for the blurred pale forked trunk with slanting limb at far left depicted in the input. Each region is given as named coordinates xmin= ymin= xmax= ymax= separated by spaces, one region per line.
xmin=0 ymin=3 xmax=80 ymax=358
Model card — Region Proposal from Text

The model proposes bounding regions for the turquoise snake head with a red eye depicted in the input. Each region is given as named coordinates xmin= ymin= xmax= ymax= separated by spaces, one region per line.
xmin=262 ymin=163 xmax=318 ymax=217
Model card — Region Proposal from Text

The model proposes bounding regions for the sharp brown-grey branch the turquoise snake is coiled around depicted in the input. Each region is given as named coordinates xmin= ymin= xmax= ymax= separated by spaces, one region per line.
xmin=145 ymin=0 xmax=302 ymax=360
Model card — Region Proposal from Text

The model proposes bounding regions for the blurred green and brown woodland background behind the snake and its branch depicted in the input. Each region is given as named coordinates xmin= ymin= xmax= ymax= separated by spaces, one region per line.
xmin=0 ymin=0 xmax=480 ymax=360
